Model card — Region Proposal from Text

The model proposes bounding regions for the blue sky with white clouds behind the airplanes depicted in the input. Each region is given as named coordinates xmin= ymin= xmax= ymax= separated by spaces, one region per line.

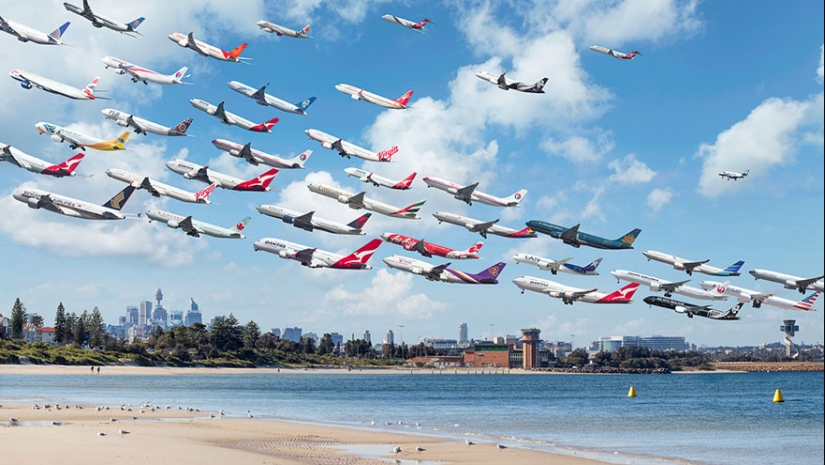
xmin=0 ymin=0 xmax=825 ymax=347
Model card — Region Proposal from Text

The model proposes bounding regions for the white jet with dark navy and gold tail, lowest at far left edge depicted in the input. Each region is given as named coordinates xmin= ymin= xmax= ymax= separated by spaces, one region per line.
xmin=12 ymin=186 xmax=140 ymax=220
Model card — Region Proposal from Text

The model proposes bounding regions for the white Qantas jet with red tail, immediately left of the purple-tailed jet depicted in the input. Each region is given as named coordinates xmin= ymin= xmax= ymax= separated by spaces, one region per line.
xmin=253 ymin=237 xmax=381 ymax=270
